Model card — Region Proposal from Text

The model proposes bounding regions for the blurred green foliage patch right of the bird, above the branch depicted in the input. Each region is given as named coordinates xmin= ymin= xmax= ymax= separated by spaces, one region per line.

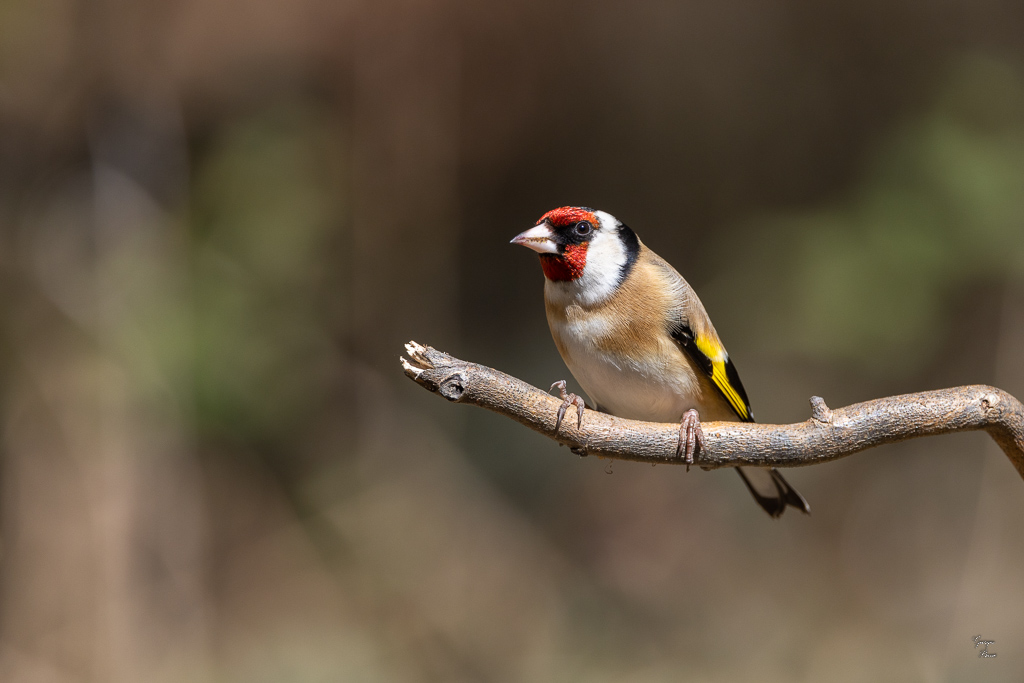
xmin=718 ymin=56 xmax=1024 ymax=375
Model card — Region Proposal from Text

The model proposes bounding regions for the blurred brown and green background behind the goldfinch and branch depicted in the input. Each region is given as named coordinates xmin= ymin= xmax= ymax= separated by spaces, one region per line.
xmin=0 ymin=0 xmax=1024 ymax=683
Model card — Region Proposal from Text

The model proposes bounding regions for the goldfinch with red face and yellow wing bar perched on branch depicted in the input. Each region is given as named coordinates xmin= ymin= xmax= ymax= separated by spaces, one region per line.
xmin=511 ymin=206 xmax=810 ymax=518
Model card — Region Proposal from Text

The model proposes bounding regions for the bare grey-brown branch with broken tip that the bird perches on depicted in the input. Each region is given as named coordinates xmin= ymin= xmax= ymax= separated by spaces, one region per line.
xmin=401 ymin=342 xmax=1024 ymax=477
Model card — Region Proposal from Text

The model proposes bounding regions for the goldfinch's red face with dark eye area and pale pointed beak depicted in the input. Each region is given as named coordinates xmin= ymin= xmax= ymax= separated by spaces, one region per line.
xmin=512 ymin=207 xmax=600 ymax=282
